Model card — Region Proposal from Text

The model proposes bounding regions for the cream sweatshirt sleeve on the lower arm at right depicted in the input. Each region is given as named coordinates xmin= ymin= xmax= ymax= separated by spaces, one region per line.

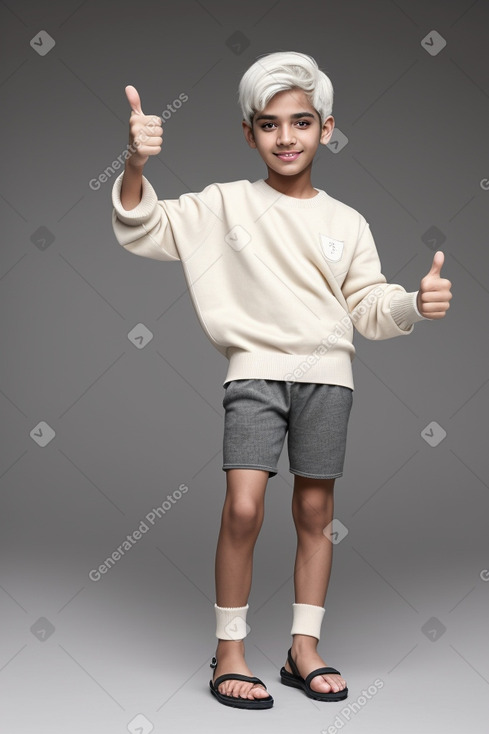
xmin=342 ymin=217 xmax=425 ymax=340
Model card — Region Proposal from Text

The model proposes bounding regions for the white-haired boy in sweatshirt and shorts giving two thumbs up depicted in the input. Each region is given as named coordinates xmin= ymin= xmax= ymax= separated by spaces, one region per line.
xmin=112 ymin=52 xmax=451 ymax=709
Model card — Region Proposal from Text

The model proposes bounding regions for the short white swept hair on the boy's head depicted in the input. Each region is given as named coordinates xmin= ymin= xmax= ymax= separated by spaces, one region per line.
xmin=238 ymin=51 xmax=333 ymax=125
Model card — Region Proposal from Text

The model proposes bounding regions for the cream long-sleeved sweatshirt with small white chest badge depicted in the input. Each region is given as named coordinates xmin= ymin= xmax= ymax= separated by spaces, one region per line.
xmin=112 ymin=173 xmax=423 ymax=389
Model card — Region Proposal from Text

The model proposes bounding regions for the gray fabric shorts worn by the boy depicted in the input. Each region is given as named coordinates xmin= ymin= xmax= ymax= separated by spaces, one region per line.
xmin=222 ymin=379 xmax=353 ymax=479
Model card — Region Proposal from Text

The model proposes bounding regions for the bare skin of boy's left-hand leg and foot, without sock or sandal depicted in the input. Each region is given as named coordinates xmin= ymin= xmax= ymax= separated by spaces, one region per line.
xmin=213 ymin=469 xmax=269 ymax=699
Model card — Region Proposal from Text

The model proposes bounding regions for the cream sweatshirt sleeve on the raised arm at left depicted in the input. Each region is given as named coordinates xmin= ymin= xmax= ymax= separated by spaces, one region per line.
xmin=112 ymin=173 xmax=218 ymax=260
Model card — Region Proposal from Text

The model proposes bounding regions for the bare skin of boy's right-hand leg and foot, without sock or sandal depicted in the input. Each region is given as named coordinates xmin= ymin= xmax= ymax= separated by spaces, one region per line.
xmin=285 ymin=475 xmax=346 ymax=693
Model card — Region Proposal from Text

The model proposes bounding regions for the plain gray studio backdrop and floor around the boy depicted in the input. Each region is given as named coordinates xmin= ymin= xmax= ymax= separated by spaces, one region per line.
xmin=0 ymin=0 xmax=489 ymax=734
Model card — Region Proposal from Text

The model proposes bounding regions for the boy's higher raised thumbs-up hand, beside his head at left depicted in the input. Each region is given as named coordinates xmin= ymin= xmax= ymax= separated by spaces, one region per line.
xmin=125 ymin=85 xmax=163 ymax=168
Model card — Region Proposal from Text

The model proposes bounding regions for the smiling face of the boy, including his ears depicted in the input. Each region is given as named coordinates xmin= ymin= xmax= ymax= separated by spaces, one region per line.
xmin=242 ymin=89 xmax=334 ymax=176
